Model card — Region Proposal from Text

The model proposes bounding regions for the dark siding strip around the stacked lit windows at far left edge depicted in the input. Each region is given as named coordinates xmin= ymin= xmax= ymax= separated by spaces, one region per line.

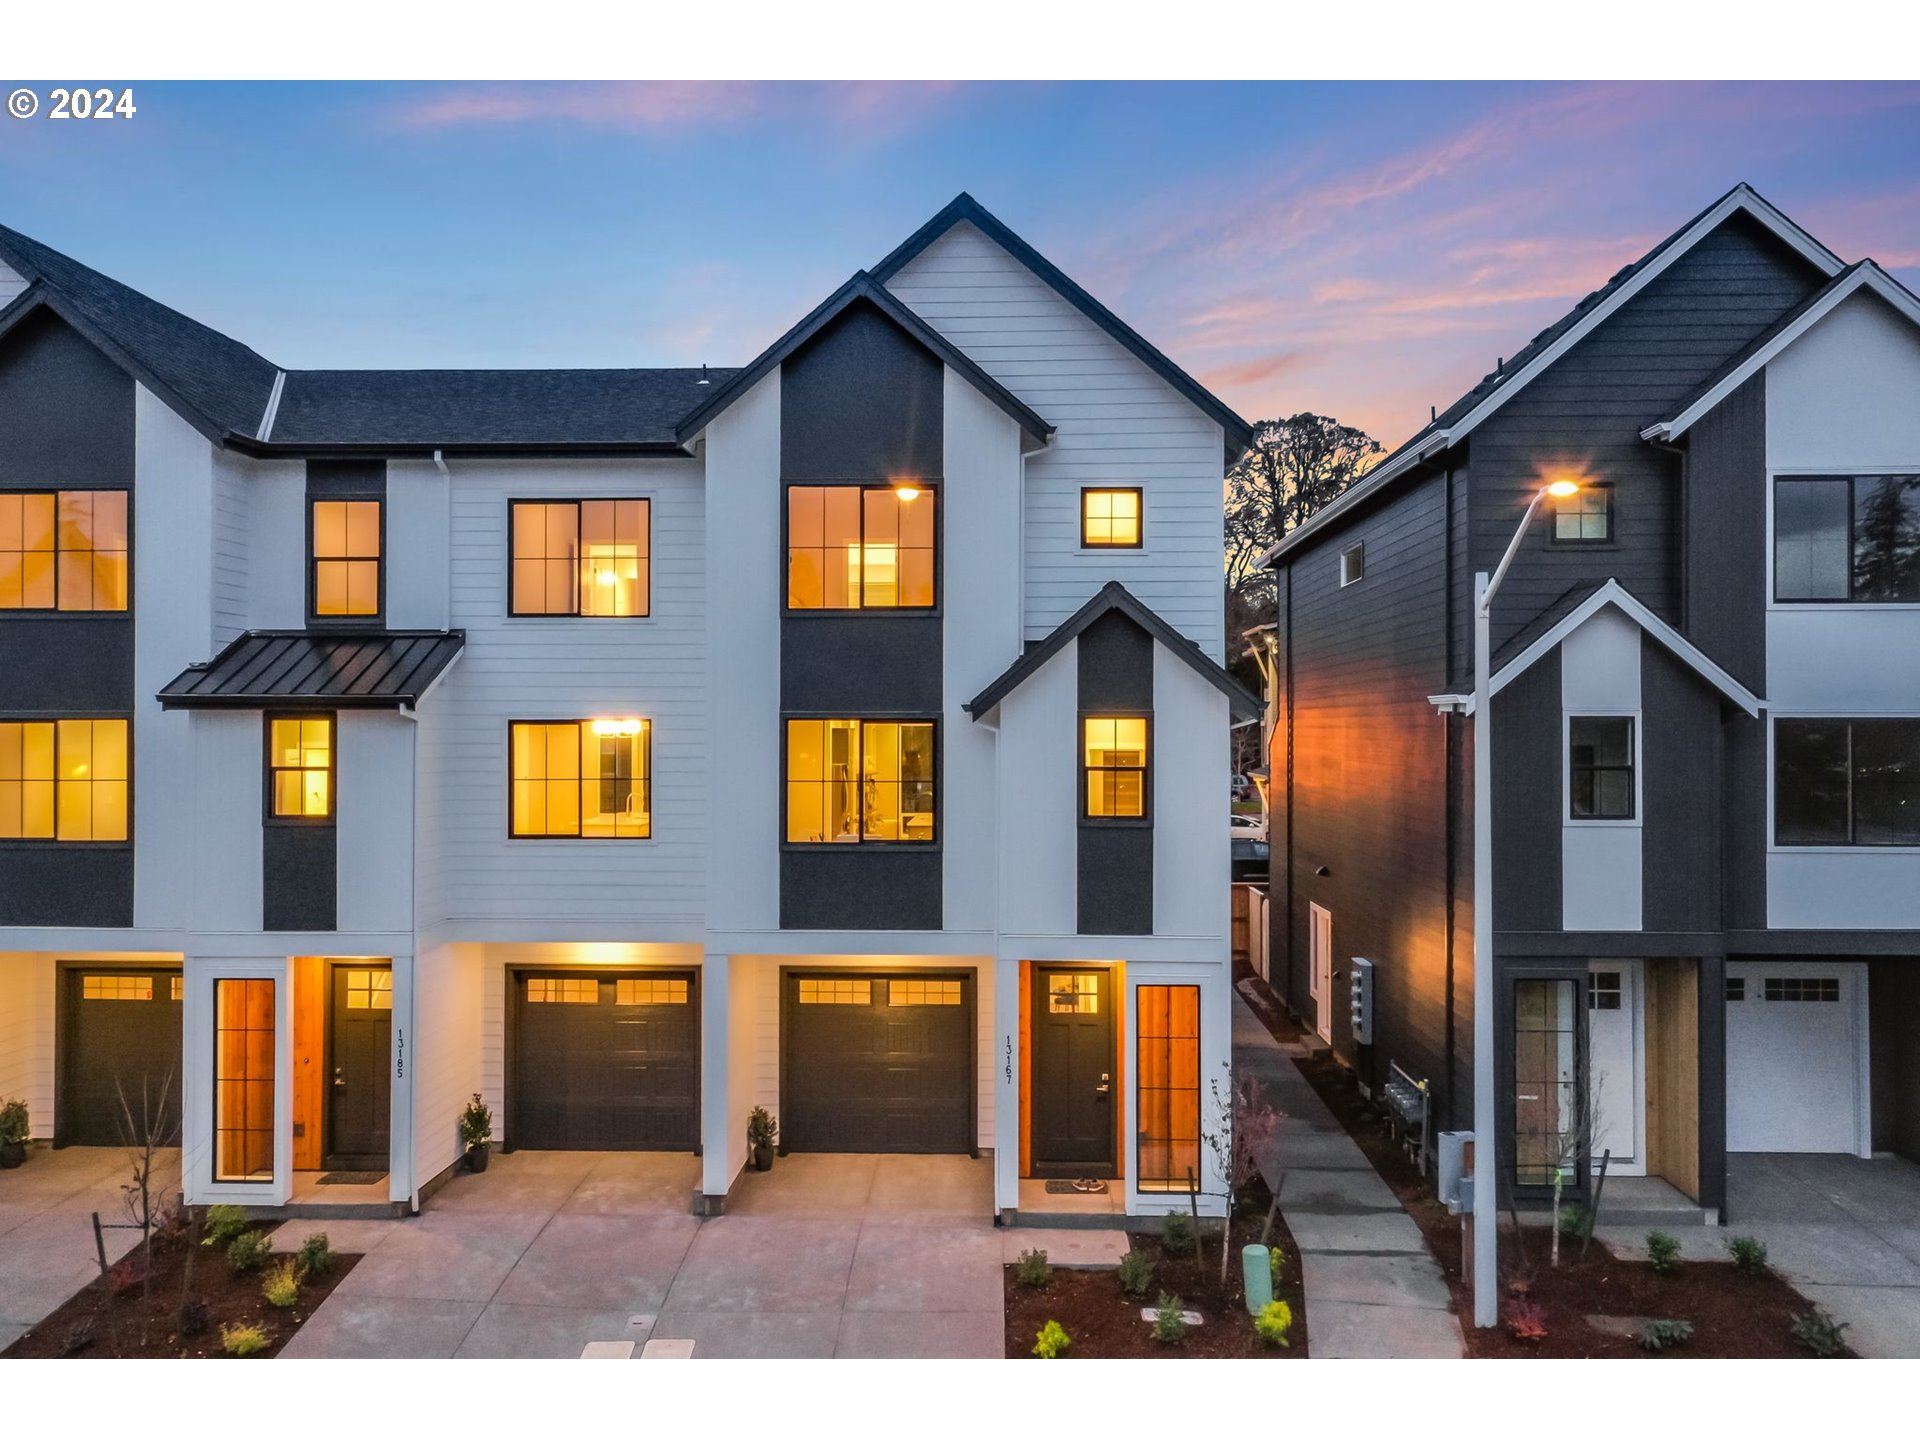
xmin=0 ymin=311 xmax=140 ymax=925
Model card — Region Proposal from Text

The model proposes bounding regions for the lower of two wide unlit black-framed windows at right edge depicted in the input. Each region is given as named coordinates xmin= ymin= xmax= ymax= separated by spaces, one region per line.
xmin=1774 ymin=716 xmax=1920 ymax=847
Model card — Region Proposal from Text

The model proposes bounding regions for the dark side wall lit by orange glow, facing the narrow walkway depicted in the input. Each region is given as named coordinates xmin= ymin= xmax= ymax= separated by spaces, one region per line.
xmin=1273 ymin=478 xmax=1473 ymax=1125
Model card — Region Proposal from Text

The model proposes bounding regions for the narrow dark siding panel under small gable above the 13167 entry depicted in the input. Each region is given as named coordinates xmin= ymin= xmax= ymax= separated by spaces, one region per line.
xmin=1073 ymin=611 xmax=1158 ymax=935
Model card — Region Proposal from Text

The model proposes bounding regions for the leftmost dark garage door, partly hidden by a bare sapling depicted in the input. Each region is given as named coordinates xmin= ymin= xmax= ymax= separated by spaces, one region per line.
xmin=56 ymin=968 xmax=184 ymax=1144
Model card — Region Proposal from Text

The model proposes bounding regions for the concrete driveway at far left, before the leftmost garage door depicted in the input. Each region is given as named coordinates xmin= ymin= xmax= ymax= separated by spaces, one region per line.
xmin=0 ymin=1146 xmax=180 ymax=1350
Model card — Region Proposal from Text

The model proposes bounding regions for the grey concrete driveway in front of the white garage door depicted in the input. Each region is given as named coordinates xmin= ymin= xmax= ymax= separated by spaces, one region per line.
xmin=1599 ymin=1156 xmax=1920 ymax=1359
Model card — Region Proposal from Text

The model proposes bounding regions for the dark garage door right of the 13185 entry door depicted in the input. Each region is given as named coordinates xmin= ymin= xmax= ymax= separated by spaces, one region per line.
xmin=507 ymin=970 xmax=699 ymax=1150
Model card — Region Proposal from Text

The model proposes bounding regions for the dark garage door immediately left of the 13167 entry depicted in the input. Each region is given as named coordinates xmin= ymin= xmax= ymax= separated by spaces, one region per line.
xmin=780 ymin=970 xmax=973 ymax=1154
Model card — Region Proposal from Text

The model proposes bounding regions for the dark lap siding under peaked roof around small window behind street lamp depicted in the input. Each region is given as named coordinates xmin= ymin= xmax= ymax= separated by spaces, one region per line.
xmin=1469 ymin=215 xmax=1824 ymax=662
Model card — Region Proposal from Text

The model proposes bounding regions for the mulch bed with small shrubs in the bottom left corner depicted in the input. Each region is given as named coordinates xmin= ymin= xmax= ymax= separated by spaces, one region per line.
xmin=0 ymin=1225 xmax=359 ymax=1359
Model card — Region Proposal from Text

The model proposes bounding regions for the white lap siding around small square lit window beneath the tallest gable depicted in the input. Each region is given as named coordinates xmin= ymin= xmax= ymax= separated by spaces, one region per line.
xmin=887 ymin=225 xmax=1225 ymax=660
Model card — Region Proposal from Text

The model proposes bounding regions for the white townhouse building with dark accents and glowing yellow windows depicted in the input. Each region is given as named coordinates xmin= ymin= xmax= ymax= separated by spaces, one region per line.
xmin=0 ymin=196 xmax=1258 ymax=1213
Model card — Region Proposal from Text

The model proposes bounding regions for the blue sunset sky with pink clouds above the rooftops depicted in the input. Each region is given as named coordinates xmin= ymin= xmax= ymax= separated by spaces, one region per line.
xmin=0 ymin=83 xmax=1920 ymax=444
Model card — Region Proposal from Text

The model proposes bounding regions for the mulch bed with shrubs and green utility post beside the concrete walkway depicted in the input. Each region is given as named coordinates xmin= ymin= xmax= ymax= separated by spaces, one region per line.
xmin=1004 ymin=1185 xmax=1308 ymax=1359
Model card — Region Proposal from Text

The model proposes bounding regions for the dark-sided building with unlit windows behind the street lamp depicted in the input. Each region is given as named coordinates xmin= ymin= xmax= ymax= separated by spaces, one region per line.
xmin=1271 ymin=186 xmax=1920 ymax=1210
